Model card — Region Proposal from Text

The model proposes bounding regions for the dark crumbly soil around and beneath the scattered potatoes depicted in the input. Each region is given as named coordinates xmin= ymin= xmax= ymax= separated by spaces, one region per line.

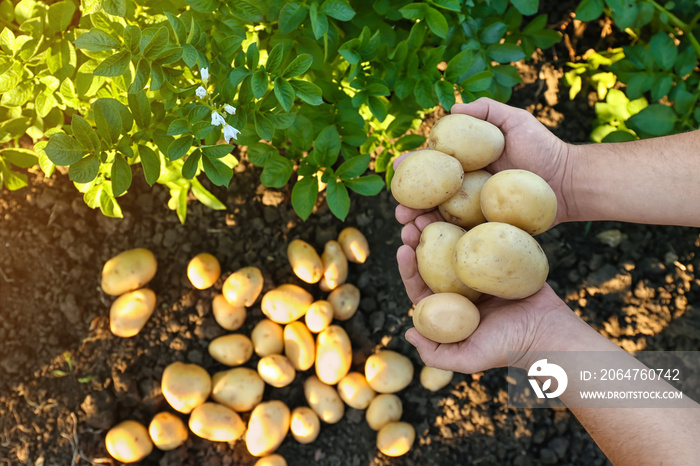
xmin=0 ymin=2 xmax=700 ymax=466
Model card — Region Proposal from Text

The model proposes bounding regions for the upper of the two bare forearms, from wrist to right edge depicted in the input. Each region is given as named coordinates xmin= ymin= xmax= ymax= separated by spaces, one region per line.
xmin=563 ymin=131 xmax=700 ymax=227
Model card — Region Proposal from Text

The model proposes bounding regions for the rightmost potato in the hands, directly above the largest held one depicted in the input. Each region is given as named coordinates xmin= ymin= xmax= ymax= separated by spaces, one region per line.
xmin=479 ymin=170 xmax=557 ymax=236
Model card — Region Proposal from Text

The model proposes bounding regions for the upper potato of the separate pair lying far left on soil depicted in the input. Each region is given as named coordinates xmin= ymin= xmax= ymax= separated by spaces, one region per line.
xmin=101 ymin=248 xmax=158 ymax=296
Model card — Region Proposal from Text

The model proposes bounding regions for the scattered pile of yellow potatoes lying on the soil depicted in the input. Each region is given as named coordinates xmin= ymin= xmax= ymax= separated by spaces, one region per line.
xmin=103 ymin=227 xmax=442 ymax=465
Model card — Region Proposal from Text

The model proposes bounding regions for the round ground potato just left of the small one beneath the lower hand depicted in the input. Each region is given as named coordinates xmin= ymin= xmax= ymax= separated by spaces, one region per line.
xmin=365 ymin=350 xmax=413 ymax=393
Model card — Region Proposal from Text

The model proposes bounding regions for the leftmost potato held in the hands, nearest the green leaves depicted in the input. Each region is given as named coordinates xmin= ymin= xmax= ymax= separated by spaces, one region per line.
xmin=391 ymin=149 xmax=464 ymax=209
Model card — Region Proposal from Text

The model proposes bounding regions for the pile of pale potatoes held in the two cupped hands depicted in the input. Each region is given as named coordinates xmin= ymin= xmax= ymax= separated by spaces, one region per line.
xmin=391 ymin=114 xmax=557 ymax=343
